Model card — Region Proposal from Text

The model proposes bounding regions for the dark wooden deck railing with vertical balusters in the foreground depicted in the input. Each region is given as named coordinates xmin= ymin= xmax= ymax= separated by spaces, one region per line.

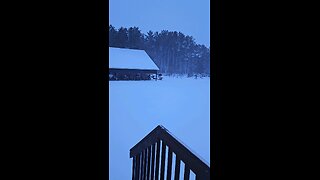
xmin=130 ymin=125 xmax=210 ymax=180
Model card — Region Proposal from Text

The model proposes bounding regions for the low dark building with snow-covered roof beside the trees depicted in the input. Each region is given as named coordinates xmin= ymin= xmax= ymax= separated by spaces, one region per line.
xmin=109 ymin=47 xmax=159 ymax=80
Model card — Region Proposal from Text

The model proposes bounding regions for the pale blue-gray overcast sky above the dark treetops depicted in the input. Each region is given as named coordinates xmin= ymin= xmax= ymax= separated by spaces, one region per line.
xmin=109 ymin=0 xmax=210 ymax=47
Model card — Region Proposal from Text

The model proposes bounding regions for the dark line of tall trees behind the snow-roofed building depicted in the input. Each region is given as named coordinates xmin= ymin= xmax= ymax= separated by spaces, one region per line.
xmin=109 ymin=25 xmax=210 ymax=76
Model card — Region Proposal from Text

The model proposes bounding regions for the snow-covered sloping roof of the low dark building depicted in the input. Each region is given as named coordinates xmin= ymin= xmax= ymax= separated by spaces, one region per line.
xmin=109 ymin=47 xmax=159 ymax=70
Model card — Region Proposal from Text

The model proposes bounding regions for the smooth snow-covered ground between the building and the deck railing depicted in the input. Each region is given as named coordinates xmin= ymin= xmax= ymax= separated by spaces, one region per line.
xmin=109 ymin=77 xmax=210 ymax=180
